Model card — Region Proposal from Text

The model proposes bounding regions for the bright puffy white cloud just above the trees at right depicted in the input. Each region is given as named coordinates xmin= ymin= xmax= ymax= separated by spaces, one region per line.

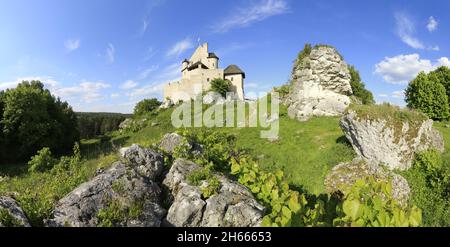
xmin=375 ymin=54 xmax=450 ymax=84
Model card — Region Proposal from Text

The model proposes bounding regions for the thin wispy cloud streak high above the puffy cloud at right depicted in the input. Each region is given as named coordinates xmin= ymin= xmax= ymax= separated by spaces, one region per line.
xmin=395 ymin=13 xmax=425 ymax=49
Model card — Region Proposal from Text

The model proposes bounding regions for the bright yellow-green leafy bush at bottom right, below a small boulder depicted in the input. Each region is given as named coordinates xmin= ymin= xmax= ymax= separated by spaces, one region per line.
xmin=334 ymin=177 xmax=422 ymax=227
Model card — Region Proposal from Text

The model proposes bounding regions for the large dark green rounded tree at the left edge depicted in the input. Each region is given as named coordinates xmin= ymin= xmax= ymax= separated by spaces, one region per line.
xmin=1 ymin=81 xmax=79 ymax=161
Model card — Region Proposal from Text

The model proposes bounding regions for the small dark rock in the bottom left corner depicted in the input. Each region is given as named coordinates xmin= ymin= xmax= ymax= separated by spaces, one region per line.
xmin=0 ymin=196 xmax=30 ymax=227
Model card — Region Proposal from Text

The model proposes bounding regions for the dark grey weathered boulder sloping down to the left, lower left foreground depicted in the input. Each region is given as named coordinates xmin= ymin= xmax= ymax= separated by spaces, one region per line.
xmin=46 ymin=145 xmax=166 ymax=227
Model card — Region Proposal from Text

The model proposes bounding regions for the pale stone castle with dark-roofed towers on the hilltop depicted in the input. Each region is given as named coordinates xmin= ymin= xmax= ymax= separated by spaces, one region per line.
xmin=164 ymin=43 xmax=245 ymax=103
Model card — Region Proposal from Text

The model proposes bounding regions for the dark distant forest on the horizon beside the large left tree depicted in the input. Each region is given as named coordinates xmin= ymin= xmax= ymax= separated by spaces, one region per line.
xmin=75 ymin=112 xmax=133 ymax=139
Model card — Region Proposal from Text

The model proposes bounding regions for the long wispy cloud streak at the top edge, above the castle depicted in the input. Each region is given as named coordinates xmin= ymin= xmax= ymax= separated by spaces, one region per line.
xmin=212 ymin=0 xmax=289 ymax=33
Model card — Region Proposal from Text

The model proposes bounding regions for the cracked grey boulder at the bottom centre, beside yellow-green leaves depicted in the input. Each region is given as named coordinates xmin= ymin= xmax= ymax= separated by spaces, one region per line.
xmin=163 ymin=159 xmax=265 ymax=227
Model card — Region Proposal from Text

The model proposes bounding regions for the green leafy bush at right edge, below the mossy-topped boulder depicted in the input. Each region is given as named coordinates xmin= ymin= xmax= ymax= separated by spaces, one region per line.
xmin=403 ymin=150 xmax=450 ymax=227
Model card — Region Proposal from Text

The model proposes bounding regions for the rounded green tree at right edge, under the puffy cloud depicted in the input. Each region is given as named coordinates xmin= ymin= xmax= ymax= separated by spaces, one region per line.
xmin=405 ymin=72 xmax=449 ymax=120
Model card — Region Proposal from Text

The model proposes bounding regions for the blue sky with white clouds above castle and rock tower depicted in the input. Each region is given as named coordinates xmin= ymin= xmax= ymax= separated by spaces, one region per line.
xmin=0 ymin=0 xmax=450 ymax=112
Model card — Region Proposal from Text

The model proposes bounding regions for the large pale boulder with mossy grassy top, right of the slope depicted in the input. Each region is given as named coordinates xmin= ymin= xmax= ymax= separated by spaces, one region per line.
xmin=340 ymin=109 xmax=444 ymax=170
